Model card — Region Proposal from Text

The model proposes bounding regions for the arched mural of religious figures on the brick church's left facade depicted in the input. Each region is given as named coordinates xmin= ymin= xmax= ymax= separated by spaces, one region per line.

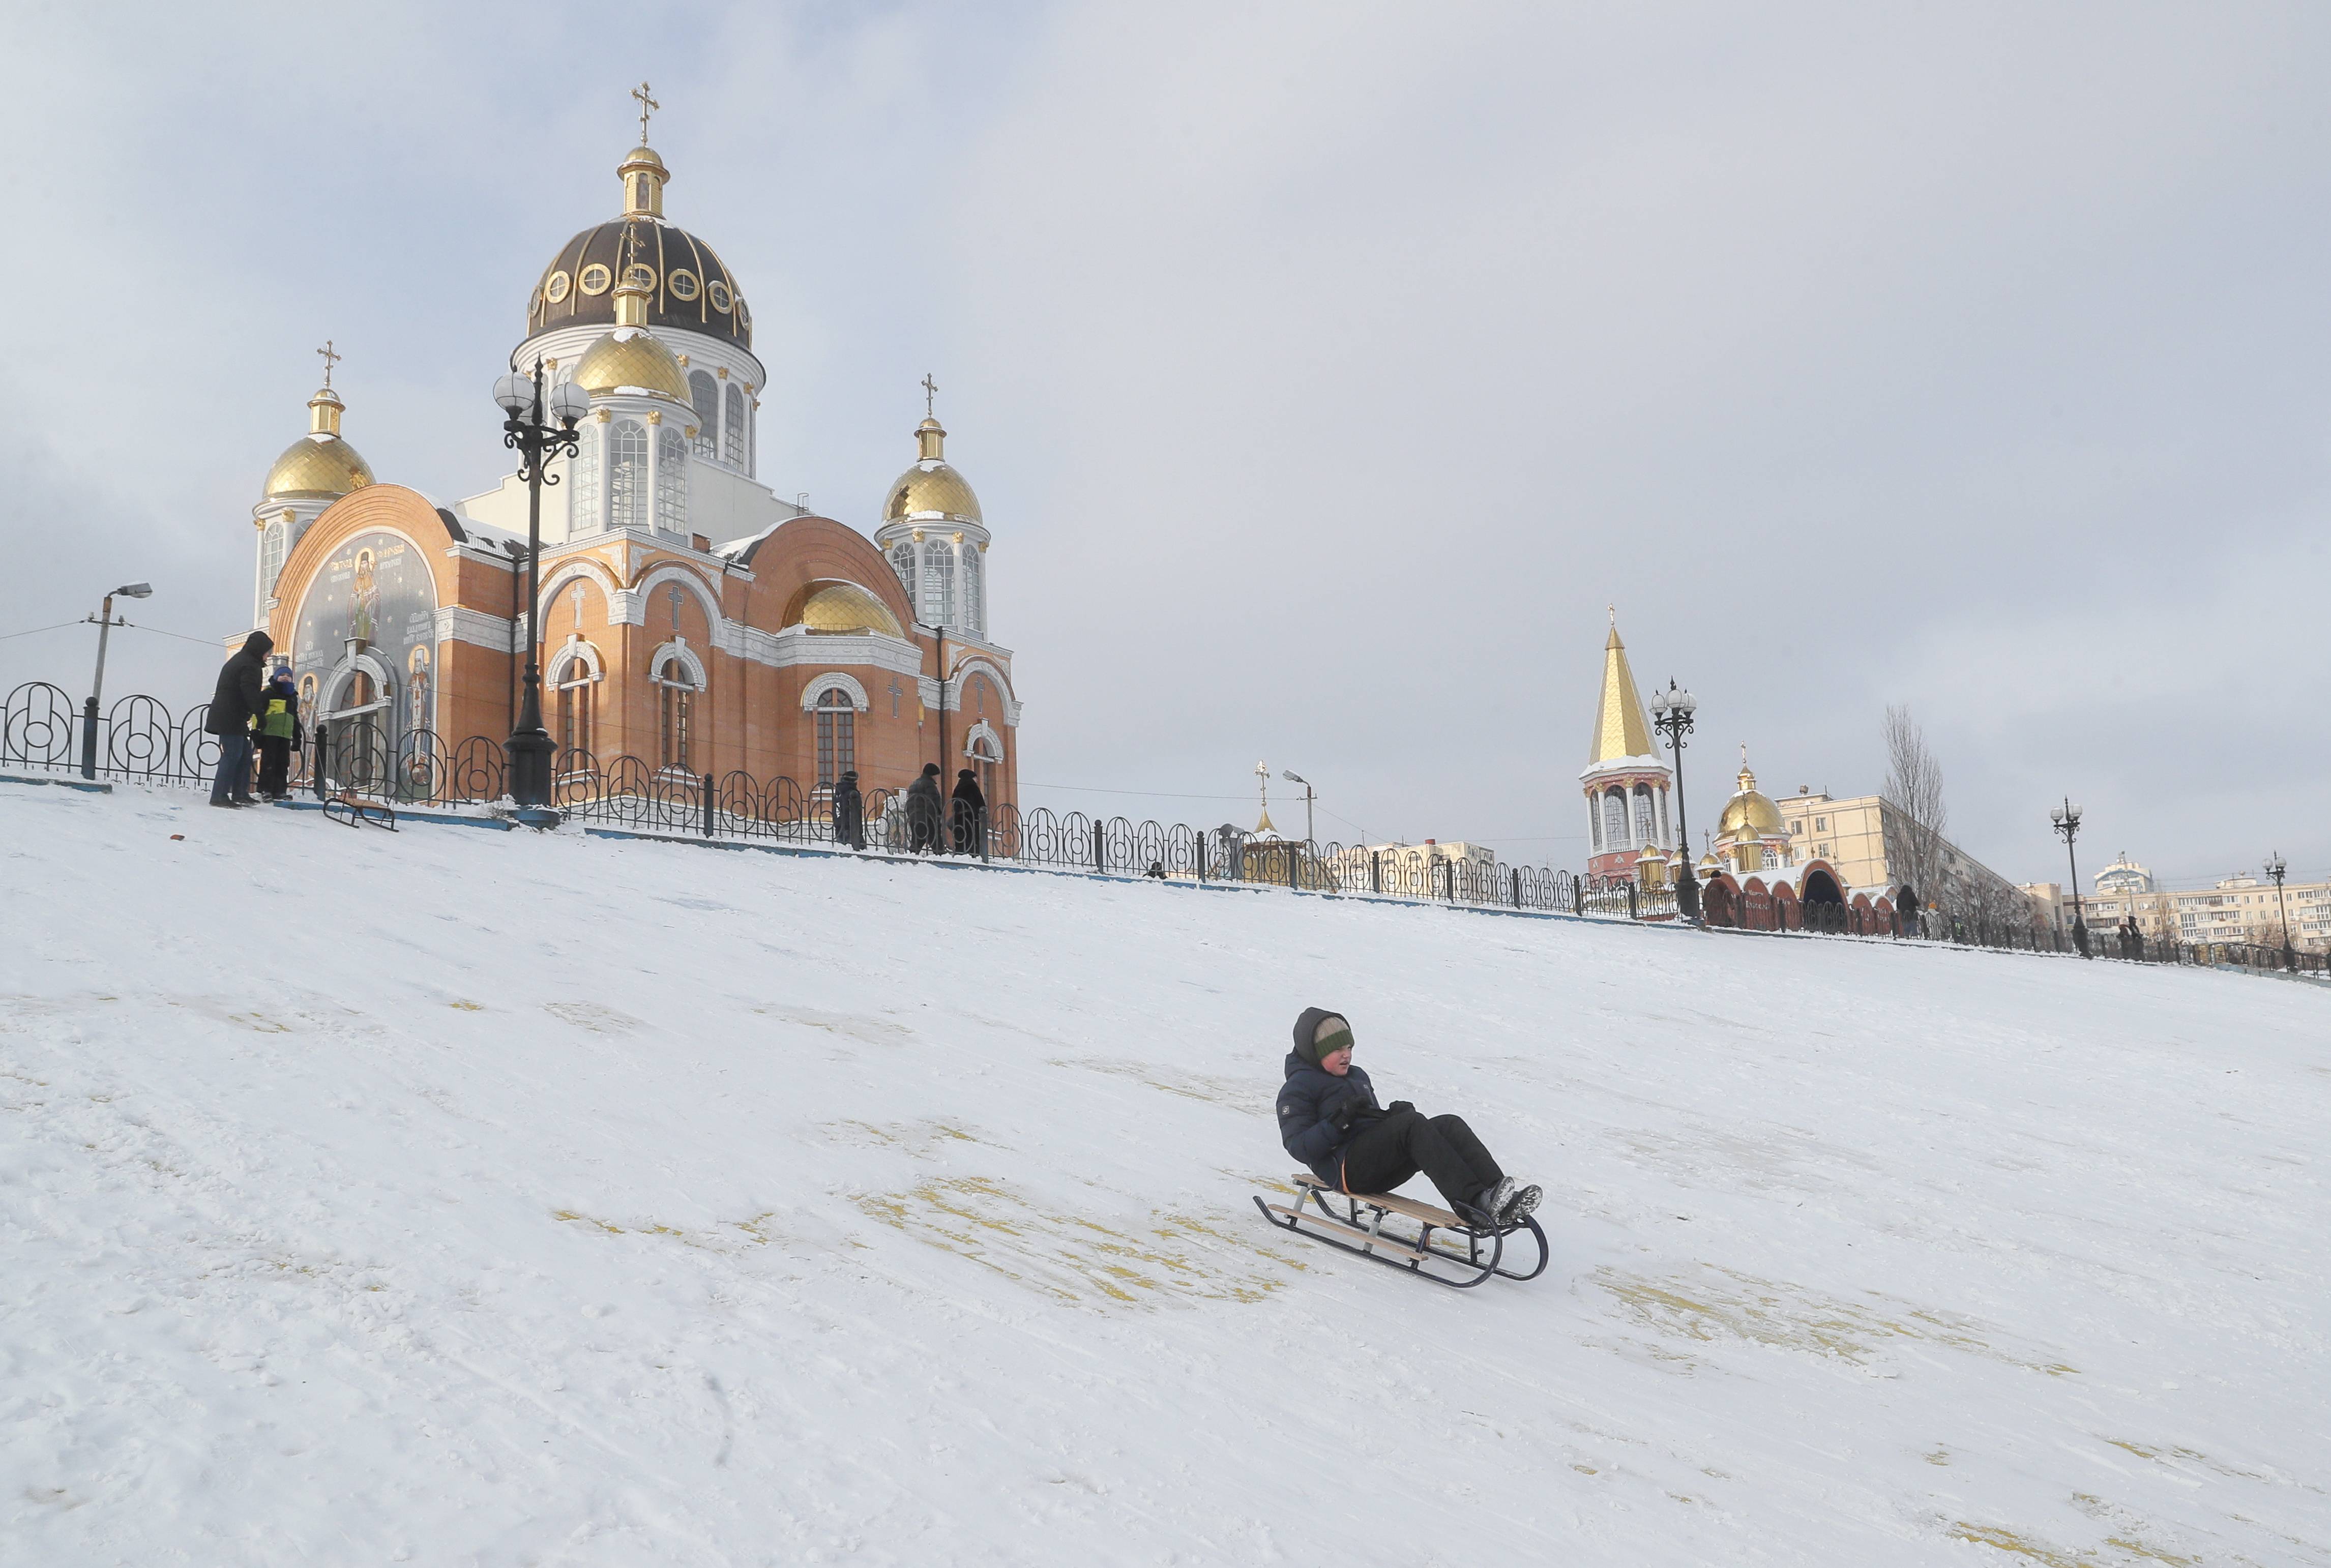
xmin=291 ymin=531 xmax=436 ymax=743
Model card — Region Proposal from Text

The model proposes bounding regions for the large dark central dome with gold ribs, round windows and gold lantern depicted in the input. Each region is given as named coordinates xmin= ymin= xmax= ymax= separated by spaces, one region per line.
xmin=527 ymin=147 xmax=753 ymax=349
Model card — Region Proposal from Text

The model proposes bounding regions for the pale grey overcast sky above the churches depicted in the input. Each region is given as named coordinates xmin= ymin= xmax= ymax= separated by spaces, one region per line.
xmin=0 ymin=3 xmax=2331 ymax=881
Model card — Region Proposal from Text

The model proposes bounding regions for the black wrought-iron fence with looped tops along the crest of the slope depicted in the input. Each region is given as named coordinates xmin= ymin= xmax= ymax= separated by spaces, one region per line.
xmin=0 ymin=681 xmax=2324 ymax=971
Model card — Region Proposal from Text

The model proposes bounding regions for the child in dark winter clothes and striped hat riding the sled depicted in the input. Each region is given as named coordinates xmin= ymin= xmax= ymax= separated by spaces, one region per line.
xmin=1280 ymin=1007 xmax=1539 ymax=1226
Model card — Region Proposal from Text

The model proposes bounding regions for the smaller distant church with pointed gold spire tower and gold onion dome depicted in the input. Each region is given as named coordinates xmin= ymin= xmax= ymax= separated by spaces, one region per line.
xmin=1578 ymin=610 xmax=1895 ymax=930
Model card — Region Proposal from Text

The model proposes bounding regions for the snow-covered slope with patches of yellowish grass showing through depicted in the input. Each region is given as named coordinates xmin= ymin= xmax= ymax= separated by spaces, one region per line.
xmin=0 ymin=785 xmax=2331 ymax=1568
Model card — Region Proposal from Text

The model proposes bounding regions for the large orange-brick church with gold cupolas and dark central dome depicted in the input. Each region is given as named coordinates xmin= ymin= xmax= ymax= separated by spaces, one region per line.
xmin=231 ymin=93 xmax=1021 ymax=804
